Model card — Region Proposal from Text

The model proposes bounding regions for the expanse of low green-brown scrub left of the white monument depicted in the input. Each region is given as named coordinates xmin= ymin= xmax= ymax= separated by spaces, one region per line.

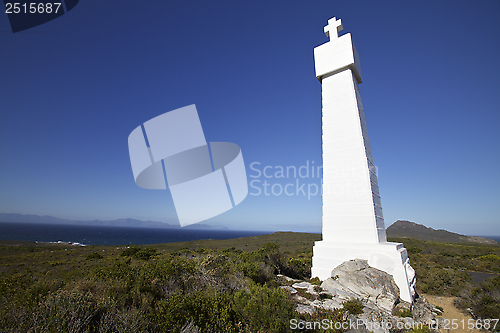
xmin=0 ymin=235 xmax=338 ymax=332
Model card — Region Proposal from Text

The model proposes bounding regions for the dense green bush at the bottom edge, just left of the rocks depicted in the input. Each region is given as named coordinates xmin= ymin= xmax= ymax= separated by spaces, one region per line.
xmin=149 ymin=284 xmax=295 ymax=332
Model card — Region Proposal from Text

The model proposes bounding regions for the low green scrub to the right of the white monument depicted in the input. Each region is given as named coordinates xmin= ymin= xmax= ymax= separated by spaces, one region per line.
xmin=391 ymin=238 xmax=500 ymax=319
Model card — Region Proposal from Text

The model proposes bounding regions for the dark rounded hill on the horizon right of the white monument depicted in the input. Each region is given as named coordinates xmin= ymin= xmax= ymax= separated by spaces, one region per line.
xmin=386 ymin=220 xmax=498 ymax=244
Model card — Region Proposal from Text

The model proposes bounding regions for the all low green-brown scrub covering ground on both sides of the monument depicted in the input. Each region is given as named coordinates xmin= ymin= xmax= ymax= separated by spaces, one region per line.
xmin=0 ymin=233 xmax=500 ymax=332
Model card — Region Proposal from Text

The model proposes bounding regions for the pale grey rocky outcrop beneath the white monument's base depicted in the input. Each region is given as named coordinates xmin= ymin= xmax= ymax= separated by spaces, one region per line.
xmin=282 ymin=259 xmax=439 ymax=333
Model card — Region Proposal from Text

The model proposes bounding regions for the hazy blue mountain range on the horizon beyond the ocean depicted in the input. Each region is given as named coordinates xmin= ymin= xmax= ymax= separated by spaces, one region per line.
xmin=0 ymin=213 xmax=227 ymax=229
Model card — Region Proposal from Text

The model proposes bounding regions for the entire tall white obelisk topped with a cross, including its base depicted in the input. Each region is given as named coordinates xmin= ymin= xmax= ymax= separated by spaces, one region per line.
xmin=311 ymin=17 xmax=415 ymax=303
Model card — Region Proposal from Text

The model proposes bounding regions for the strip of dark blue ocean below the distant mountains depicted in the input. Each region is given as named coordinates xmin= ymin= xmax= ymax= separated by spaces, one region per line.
xmin=0 ymin=222 xmax=271 ymax=245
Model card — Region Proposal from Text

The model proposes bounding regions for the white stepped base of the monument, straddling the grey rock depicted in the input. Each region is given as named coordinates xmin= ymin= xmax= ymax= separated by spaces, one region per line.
xmin=311 ymin=241 xmax=415 ymax=304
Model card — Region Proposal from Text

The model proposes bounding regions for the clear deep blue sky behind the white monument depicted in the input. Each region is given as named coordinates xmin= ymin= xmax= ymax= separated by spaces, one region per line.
xmin=0 ymin=0 xmax=500 ymax=235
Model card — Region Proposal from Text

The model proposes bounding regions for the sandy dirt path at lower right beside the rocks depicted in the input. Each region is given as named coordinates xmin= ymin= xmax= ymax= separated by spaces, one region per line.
xmin=424 ymin=294 xmax=480 ymax=333
